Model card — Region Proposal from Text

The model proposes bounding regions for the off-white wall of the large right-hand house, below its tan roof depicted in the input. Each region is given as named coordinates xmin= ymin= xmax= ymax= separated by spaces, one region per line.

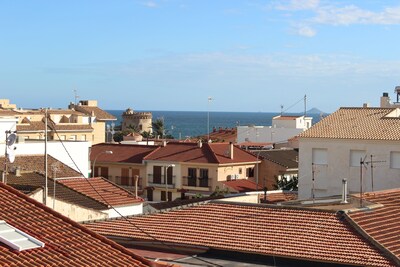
xmin=299 ymin=138 xmax=400 ymax=199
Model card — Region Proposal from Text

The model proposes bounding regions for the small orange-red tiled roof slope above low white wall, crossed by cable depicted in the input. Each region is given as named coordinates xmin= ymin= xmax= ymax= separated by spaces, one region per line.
xmin=58 ymin=177 xmax=143 ymax=206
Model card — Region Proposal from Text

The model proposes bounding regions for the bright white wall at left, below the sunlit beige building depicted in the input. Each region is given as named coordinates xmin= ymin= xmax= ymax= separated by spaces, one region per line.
xmin=0 ymin=141 xmax=90 ymax=177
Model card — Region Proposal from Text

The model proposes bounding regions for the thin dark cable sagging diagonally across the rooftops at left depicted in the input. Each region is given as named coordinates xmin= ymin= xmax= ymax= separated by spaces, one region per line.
xmin=49 ymin=118 xmax=222 ymax=267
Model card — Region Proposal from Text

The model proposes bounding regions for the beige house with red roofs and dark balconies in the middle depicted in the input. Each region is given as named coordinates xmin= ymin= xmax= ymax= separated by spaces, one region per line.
xmin=90 ymin=142 xmax=257 ymax=201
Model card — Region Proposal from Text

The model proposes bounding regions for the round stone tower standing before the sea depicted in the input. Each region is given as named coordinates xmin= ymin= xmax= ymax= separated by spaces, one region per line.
xmin=121 ymin=108 xmax=153 ymax=133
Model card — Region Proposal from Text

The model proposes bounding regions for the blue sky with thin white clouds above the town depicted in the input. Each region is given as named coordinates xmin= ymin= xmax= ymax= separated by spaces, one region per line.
xmin=0 ymin=0 xmax=400 ymax=113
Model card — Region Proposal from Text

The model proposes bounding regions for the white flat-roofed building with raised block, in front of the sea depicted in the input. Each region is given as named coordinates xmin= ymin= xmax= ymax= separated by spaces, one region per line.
xmin=237 ymin=116 xmax=312 ymax=143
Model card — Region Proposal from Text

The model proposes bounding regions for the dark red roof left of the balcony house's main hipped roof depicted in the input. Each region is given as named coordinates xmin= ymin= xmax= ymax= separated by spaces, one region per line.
xmin=90 ymin=144 xmax=158 ymax=164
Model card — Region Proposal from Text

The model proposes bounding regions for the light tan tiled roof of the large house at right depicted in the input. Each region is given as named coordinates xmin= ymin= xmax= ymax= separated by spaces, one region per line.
xmin=299 ymin=108 xmax=400 ymax=140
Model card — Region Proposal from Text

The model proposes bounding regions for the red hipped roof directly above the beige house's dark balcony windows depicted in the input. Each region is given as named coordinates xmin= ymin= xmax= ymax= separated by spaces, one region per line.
xmin=145 ymin=142 xmax=256 ymax=164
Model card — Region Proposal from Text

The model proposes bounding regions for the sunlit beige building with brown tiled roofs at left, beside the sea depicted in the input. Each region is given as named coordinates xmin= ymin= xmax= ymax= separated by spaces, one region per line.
xmin=0 ymin=99 xmax=116 ymax=144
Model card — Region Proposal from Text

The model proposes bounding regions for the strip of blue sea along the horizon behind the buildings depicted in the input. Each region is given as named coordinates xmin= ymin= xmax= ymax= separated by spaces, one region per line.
xmin=106 ymin=110 xmax=321 ymax=140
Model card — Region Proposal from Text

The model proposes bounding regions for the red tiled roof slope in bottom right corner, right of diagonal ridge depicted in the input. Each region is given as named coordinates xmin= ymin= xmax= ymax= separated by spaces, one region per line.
xmin=349 ymin=189 xmax=400 ymax=262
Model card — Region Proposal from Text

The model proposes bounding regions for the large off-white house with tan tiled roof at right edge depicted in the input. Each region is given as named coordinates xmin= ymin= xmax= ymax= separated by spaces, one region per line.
xmin=299 ymin=107 xmax=400 ymax=199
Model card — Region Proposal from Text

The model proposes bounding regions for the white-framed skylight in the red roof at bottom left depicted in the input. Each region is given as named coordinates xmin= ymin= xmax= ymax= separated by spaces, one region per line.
xmin=0 ymin=221 xmax=44 ymax=251
